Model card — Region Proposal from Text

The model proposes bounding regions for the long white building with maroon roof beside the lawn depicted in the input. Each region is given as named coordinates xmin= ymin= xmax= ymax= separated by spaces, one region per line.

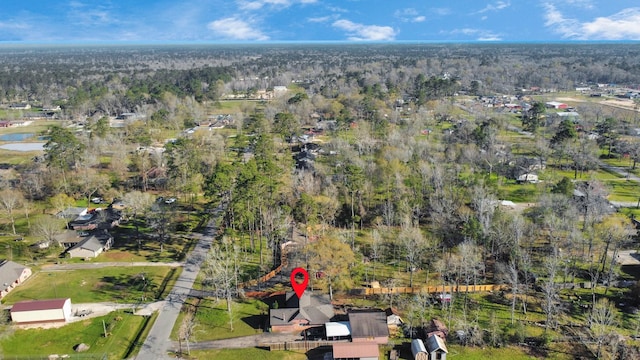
xmin=11 ymin=298 xmax=71 ymax=324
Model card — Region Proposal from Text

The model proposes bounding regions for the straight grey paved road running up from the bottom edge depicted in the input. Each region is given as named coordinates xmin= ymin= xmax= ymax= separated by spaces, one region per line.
xmin=136 ymin=208 xmax=222 ymax=360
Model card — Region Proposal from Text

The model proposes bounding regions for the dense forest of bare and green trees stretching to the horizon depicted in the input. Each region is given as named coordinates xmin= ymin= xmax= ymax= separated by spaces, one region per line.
xmin=0 ymin=44 xmax=640 ymax=359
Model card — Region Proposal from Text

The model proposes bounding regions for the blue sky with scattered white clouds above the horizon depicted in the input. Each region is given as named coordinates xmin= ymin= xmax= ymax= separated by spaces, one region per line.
xmin=0 ymin=0 xmax=640 ymax=43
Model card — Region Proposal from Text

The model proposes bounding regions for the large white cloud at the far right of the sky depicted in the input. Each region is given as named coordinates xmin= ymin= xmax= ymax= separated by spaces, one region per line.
xmin=544 ymin=3 xmax=640 ymax=40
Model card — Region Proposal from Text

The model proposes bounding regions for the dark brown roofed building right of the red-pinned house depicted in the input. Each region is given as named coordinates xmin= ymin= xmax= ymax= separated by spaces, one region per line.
xmin=349 ymin=310 xmax=389 ymax=344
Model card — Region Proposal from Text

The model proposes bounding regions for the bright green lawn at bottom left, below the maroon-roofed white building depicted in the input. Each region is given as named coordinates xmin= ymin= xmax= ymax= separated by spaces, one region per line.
xmin=0 ymin=312 xmax=145 ymax=360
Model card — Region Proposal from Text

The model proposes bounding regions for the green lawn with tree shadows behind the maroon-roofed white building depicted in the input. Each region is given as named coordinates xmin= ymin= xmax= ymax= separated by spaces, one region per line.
xmin=3 ymin=266 xmax=179 ymax=304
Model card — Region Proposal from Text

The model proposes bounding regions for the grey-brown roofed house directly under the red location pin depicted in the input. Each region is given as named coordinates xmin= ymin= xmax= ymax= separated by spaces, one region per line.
xmin=269 ymin=290 xmax=334 ymax=332
